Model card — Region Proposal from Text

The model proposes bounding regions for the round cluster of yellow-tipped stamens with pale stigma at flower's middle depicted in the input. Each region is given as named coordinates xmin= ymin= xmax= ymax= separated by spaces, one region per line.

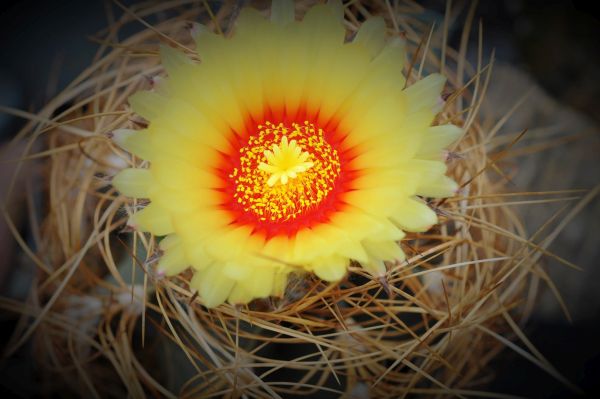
xmin=229 ymin=121 xmax=340 ymax=222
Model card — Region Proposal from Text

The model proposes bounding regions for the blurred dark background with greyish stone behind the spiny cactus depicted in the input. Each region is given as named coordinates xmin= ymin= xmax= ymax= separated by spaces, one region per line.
xmin=0 ymin=0 xmax=600 ymax=398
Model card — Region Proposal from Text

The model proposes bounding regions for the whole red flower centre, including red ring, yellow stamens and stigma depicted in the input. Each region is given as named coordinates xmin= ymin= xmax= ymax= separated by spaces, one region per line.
xmin=221 ymin=111 xmax=352 ymax=238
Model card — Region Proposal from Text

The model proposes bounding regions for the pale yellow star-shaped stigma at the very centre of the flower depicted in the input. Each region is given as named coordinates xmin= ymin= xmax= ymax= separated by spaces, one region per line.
xmin=258 ymin=136 xmax=314 ymax=187
